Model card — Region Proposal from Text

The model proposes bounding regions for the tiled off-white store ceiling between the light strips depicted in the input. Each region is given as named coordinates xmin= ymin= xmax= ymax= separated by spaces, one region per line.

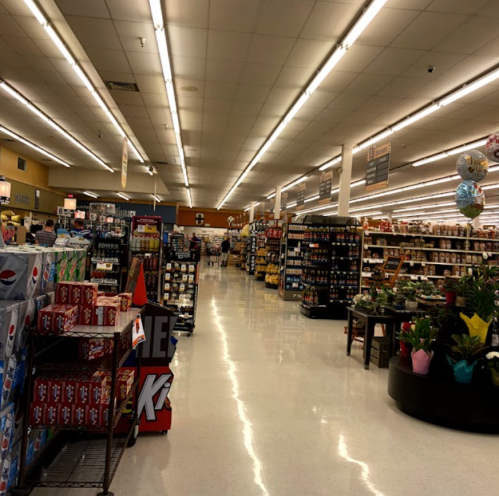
xmin=0 ymin=0 xmax=499 ymax=208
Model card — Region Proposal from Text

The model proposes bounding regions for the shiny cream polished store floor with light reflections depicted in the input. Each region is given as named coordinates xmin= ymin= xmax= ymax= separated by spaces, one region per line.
xmin=35 ymin=267 xmax=499 ymax=496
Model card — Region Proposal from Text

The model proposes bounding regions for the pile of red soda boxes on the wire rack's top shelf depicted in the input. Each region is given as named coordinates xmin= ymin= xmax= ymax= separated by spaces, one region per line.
xmin=38 ymin=282 xmax=132 ymax=334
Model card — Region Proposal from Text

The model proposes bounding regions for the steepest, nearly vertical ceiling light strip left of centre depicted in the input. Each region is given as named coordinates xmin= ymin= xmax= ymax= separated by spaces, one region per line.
xmin=149 ymin=0 xmax=192 ymax=208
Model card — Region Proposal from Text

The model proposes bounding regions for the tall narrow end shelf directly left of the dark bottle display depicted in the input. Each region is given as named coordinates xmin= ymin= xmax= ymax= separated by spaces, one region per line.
xmin=278 ymin=223 xmax=308 ymax=301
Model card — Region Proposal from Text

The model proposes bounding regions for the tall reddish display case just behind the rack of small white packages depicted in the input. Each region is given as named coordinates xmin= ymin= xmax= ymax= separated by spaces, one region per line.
xmin=129 ymin=215 xmax=163 ymax=303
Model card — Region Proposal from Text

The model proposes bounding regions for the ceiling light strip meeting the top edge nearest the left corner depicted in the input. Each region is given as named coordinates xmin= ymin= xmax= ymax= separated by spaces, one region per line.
xmin=24 ymin=0 xmax=144 ymax=164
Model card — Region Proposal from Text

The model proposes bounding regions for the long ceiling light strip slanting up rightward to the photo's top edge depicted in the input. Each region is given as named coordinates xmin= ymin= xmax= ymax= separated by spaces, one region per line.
xmin=217 ymin=0 xmax=387 ymax=210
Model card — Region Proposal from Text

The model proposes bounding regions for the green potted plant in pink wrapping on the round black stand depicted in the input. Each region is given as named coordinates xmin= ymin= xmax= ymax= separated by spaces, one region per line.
xmin=398 ymin=318 xmax=438 ymax=375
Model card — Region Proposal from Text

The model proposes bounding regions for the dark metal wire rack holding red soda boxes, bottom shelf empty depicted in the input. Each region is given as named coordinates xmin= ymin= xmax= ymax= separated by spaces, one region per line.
xmin=17 ymin=309 xmax=142 ymax=495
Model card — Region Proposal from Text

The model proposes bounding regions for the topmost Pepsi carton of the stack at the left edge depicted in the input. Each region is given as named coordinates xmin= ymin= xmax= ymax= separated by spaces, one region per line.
xmin=0 ymin=250 xmax=43 ymax=300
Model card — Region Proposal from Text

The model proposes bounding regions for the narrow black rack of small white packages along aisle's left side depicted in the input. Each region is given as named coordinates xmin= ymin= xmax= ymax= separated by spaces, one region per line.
xmin=164 ymin=260 xmax=199 ymax=336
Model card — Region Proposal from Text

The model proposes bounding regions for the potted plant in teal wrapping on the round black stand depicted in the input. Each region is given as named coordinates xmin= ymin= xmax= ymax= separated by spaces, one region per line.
xmin=447 ymin=334 xmax=485 ymax=384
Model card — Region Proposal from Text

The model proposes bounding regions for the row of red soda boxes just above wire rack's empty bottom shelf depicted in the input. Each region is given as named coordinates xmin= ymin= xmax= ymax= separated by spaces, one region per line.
xmin=30 ymin=369 xmax=135 ymax=428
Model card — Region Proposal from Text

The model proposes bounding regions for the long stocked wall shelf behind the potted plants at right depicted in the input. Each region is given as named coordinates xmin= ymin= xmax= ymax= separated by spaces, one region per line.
xmin=362 ymin=228 xmax=499 ymax=289
